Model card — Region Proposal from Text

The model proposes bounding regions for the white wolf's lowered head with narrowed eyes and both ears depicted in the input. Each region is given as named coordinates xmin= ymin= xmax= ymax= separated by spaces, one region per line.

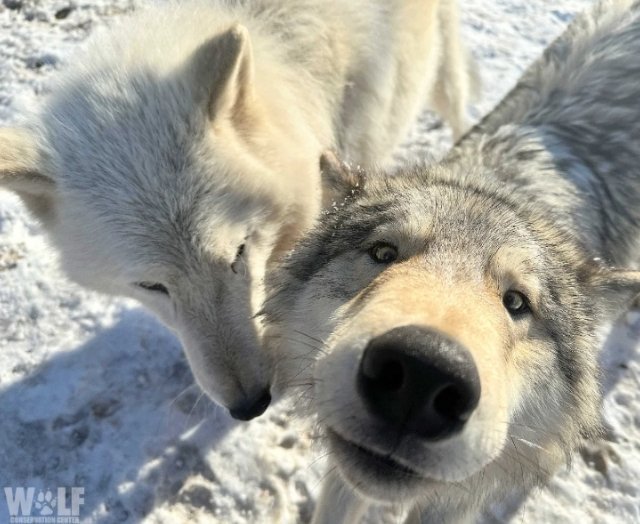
xmin=0 ymin=22 xmax=319 ymax=419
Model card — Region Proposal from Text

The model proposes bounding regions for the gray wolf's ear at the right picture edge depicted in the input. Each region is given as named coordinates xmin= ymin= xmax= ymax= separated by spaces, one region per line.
xmin=587 ymin=268 xmax=640 ymax=316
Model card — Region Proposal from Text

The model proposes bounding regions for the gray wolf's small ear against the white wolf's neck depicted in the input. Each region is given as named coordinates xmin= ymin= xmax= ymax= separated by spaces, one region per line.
xmin=320 ymin=151 xmax=366 ymax=207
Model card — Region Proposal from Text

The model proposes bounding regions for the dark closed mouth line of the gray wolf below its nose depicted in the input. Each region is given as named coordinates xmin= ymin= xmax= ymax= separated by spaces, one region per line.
xmin=327 ymin=428 xmax=429 ymax=483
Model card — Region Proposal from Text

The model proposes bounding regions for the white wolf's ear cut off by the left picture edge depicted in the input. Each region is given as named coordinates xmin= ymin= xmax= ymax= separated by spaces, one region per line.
xmin=0 ymin=128 xmax=56 ymax=222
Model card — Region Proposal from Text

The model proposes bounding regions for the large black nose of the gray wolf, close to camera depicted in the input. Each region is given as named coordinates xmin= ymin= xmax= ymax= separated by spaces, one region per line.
xmin=358 ymin=326 xmax=480 ymax=440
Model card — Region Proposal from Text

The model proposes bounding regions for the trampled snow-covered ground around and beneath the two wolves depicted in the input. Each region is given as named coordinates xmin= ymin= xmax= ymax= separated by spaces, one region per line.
xmin=0 ymin=0 xmax=640 ymax=524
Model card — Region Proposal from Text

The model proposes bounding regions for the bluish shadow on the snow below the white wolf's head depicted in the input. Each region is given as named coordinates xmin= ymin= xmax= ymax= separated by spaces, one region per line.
xmin=0 ymin=309 xmax=235 ymax=524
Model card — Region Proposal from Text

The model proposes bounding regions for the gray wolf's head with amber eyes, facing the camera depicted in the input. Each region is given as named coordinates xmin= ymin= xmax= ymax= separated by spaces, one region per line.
xmin=265 ymin=167 xmax=640 ymax=507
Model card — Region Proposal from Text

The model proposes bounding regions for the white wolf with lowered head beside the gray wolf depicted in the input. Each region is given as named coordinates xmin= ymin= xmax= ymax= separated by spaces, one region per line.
xmin=0 ymin=0 xmax=471 ymax=419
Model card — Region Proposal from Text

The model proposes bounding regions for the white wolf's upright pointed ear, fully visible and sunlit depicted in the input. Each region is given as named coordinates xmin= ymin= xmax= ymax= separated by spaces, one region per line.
xmin=192 ymin=24 xmax=254 ymax=121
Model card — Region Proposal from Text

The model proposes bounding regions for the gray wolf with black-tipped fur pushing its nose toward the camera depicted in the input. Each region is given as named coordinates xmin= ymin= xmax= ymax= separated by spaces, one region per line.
xmin=264 ymin=0 xmax=640 ymax=523
